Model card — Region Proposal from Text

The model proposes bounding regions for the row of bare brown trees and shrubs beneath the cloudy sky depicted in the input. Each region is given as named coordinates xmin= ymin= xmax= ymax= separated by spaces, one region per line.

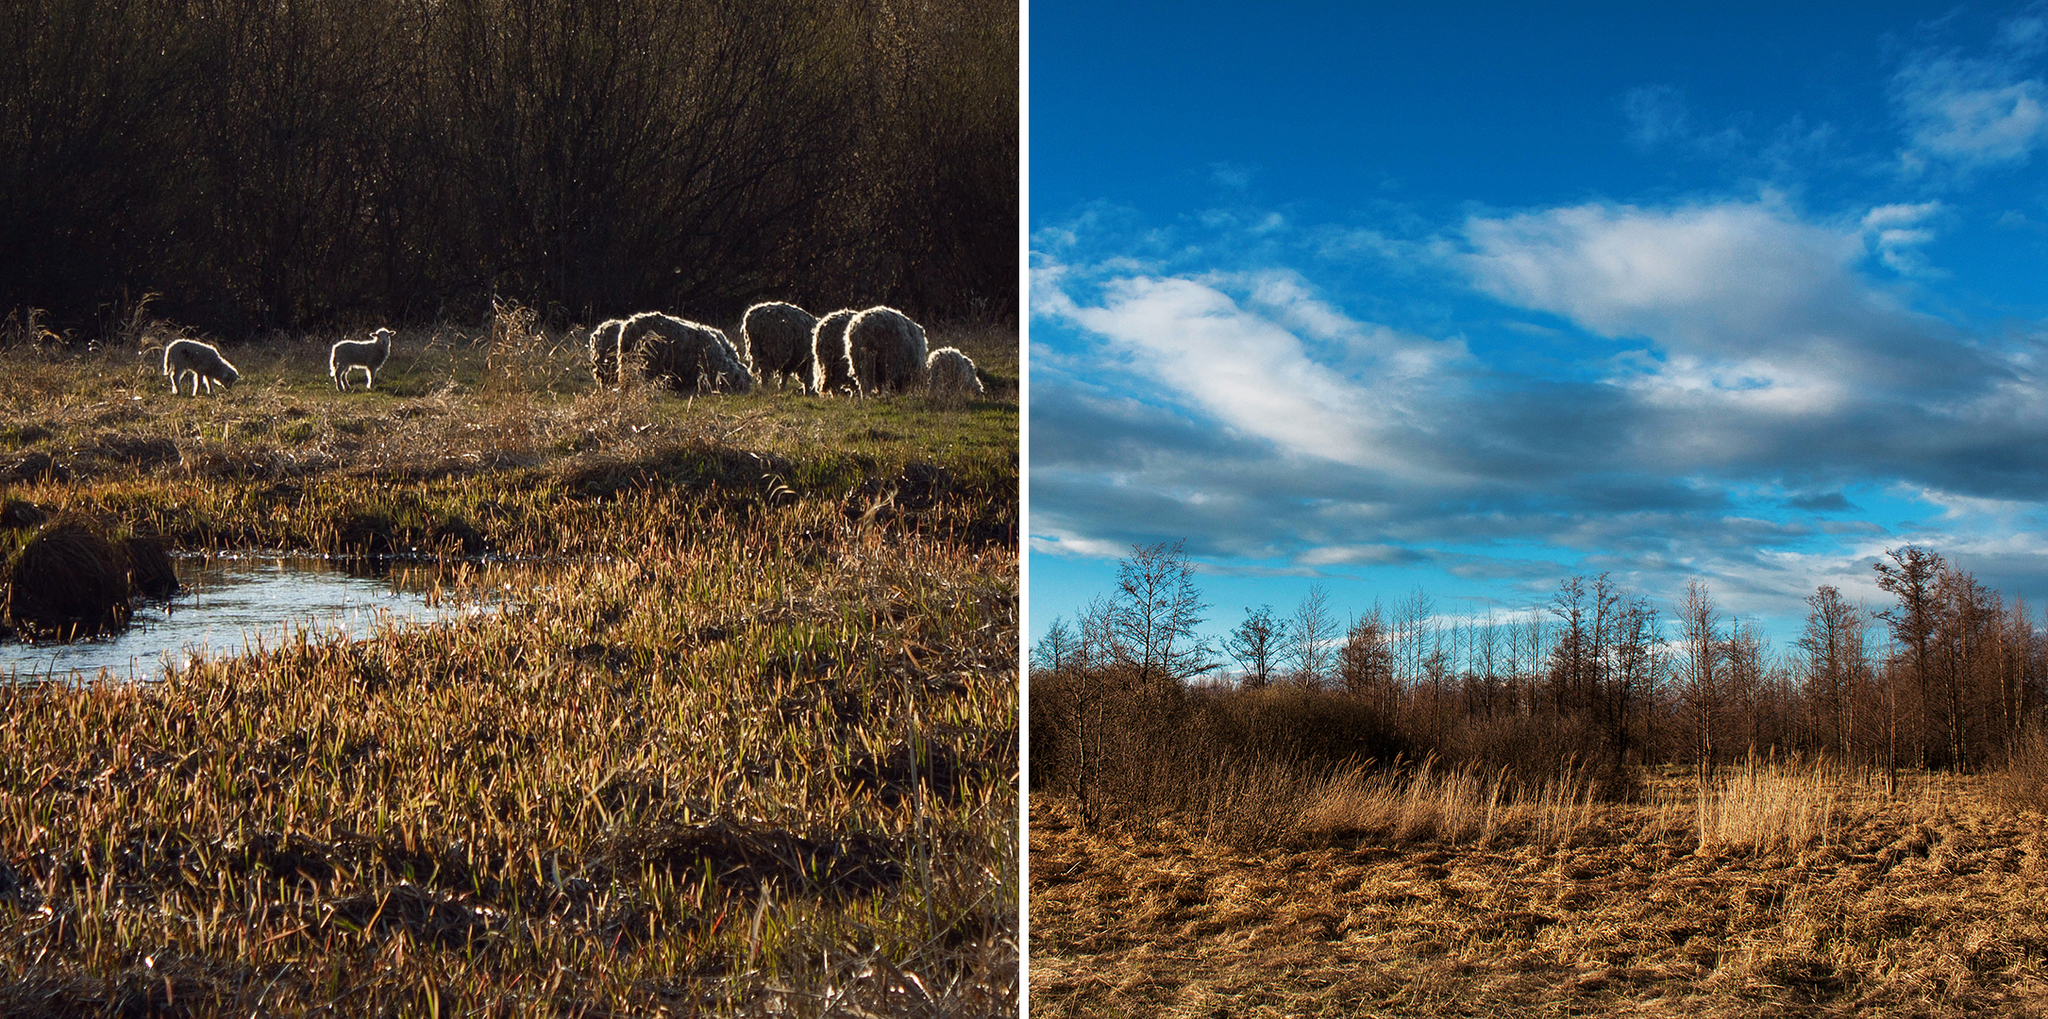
xmin=1032 ymin=544 xmax=2048 ymax=818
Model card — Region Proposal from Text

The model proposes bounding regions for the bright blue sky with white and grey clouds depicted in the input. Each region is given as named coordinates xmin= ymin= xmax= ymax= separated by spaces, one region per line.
xmin=1030 ymin=2 xmax=2048 ymax=649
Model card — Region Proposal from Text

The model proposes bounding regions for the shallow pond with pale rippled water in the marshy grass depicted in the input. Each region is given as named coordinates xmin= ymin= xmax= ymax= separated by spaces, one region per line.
xmin=0 ymin=555 xmax=499 ymax=681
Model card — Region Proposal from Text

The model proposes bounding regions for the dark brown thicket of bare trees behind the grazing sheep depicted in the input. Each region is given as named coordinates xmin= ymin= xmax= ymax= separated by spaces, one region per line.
xmin=0 ymin=0 xmax=1018 ymax=336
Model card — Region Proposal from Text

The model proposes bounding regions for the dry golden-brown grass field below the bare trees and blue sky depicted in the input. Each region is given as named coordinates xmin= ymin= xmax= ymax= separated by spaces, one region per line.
xmin=1030 ymin=767 xmax=2048 ymax=1017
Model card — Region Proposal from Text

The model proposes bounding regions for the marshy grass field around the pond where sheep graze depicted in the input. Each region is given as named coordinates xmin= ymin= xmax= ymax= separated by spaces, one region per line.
xmin=0 ymin=315 xmax=1020 ymax=1015
